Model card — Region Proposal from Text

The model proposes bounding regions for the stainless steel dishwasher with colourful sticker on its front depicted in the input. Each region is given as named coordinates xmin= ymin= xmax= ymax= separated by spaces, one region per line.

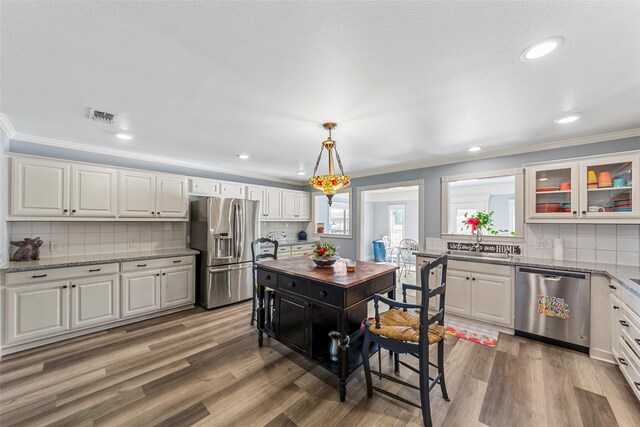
xmin=515 ymin=267 xmax=592 ymax=352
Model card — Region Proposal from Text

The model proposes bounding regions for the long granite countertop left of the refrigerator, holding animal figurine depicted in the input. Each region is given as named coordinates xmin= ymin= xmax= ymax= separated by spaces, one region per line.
xmin=0 ymin=248 xmax=200 ymax=273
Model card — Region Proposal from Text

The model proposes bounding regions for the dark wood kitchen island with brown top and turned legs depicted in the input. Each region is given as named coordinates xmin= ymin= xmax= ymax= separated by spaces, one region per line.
xmin=257 ymin=256 xmax=396 ymax=402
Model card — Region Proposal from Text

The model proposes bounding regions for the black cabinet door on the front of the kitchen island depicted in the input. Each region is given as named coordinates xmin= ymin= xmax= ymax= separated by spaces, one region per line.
xmin=276 ymin=295 xmax=308 ymax=354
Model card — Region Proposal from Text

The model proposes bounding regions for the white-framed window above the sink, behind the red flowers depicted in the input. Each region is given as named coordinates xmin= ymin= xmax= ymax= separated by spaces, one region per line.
xmin=442 ymin=169 xmax=524 ymax=238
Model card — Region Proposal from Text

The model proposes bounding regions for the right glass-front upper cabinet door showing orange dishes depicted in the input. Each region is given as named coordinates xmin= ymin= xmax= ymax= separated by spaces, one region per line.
xmin=580 ymin=154 xmax=640 ymax=220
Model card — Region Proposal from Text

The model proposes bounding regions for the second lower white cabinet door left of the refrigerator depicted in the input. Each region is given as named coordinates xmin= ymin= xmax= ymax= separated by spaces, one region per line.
xmin=122 ymin=270 xmax=160 ymax=317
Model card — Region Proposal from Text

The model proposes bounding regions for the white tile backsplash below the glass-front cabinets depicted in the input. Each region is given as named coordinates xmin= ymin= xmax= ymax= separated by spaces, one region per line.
xmin=426 ymin=224 xmax=640 ymax=265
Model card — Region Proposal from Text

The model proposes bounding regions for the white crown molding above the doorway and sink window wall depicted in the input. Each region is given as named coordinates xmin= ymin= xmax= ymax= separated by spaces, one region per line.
xmin=350 ymin=128 xmax=640 ymax=178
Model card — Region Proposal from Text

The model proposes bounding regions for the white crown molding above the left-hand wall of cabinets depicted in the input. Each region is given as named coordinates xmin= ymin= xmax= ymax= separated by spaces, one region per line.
xmin=10 ymin=133 xmax=303 ymax=185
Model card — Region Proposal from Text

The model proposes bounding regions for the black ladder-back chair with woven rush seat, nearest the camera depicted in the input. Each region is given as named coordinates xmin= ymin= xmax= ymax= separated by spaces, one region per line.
xmin=362 ymin=255 xmax=449 ymax=426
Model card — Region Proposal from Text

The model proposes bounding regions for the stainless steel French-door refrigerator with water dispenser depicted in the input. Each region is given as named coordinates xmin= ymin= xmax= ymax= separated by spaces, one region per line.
xmin=191 ymin=197 xmax=260 ymax=309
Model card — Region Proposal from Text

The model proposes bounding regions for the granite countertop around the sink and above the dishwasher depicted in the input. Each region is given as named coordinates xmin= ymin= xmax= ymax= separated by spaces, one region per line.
xmin=414 ymin=251 xmax=640 ymax=297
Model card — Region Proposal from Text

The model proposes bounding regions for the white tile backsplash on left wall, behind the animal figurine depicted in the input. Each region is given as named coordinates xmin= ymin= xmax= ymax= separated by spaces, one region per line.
xmin=7 ymin=221 xmax=188 ymax=258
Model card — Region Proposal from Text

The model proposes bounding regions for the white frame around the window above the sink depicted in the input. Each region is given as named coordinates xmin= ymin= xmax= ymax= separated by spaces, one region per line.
xmin=440 ymin=168 xmax=524 ymax=243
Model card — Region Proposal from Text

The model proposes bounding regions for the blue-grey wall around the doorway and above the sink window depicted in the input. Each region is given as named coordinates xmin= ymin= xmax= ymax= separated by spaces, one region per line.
xmin=325 ymin=137 xmax=640 ymax=258
